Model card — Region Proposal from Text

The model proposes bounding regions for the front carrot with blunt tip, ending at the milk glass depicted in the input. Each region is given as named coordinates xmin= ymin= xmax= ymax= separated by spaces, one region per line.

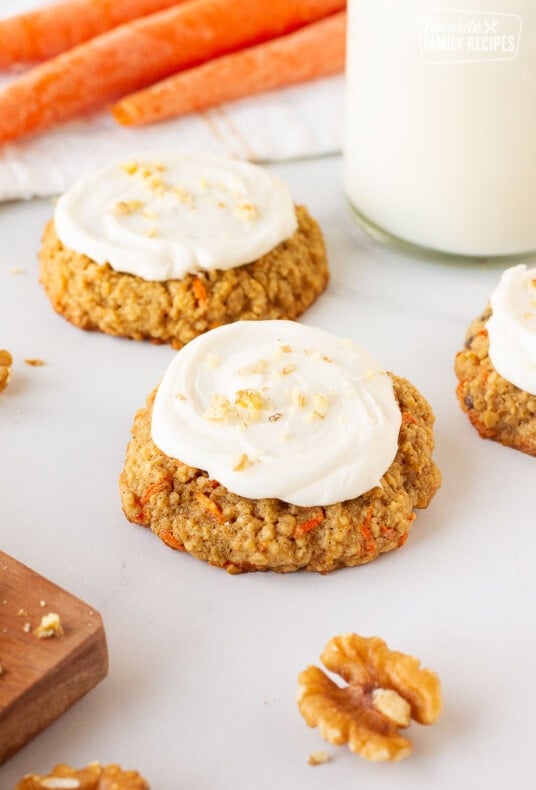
xmin=112 ymin=11 xmax=346 ymax=126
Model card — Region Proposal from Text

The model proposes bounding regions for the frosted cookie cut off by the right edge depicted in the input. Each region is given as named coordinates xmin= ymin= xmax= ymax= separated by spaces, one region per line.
xmin=455 ymin=264 xmax=536 ymax=455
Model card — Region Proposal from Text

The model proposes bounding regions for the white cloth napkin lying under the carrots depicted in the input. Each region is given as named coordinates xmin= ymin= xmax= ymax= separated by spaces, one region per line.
xmin=0 ymin=0 xmax=344 ymax=200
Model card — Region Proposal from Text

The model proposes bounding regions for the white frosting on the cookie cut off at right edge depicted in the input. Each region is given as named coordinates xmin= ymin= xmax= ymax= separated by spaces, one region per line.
xmin=487 ymin=264 xmax=536 ymax=395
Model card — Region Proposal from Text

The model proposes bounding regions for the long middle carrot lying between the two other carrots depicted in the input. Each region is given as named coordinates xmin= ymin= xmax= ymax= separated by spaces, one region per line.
xmin=0 ymin=0 xmax=345 ymax=142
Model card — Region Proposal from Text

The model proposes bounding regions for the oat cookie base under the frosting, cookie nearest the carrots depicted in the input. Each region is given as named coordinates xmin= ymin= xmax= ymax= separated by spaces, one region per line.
xmin=39 ymin=206 xmax=329 ymax=348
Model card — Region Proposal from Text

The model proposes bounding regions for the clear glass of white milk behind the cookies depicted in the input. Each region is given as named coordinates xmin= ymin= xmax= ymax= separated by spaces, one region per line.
xmin=345 ymin=0 xmax=536 ymax=256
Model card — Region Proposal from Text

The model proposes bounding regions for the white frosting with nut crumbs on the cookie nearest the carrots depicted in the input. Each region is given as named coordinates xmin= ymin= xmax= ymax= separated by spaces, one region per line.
xmin=54 ymin=151 xmax=297 ymax=280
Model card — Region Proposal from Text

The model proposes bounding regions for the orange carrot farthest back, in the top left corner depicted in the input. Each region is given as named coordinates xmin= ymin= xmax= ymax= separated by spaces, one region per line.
xmin=0 ymin=0 xmax=186 ymax=68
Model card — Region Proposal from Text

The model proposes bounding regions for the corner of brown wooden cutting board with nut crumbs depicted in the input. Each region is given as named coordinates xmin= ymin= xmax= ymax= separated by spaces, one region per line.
xmin=0 ymin=551 xmax=108 ymax=765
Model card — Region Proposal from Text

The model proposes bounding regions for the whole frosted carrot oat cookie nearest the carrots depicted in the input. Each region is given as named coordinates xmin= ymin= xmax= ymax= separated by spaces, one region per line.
xmin=39 ymin=151 xmax=329 ymax=348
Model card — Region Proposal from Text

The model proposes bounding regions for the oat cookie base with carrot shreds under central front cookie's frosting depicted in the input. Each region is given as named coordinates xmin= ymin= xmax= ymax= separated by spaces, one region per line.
xmin=120 ymin=376 xmax=441 ymax=573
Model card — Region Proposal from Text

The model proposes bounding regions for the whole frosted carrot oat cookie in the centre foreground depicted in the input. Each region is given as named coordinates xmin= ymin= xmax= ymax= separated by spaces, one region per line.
xmin=120 ymin=321 xmax=441 ymax=573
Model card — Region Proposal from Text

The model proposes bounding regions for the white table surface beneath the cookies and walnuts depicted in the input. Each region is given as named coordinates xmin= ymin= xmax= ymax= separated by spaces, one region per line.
xmin=0 ymin=152 xmax=536 ymax=790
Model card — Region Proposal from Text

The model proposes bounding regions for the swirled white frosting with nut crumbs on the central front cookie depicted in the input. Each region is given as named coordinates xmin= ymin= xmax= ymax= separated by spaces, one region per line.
xmin=152 ymin=320 xmax=401 ymax=507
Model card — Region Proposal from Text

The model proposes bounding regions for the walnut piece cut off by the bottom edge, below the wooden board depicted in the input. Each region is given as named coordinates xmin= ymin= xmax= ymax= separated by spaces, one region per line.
xmin=15 ymin=763 xmax=149 ymax=790
